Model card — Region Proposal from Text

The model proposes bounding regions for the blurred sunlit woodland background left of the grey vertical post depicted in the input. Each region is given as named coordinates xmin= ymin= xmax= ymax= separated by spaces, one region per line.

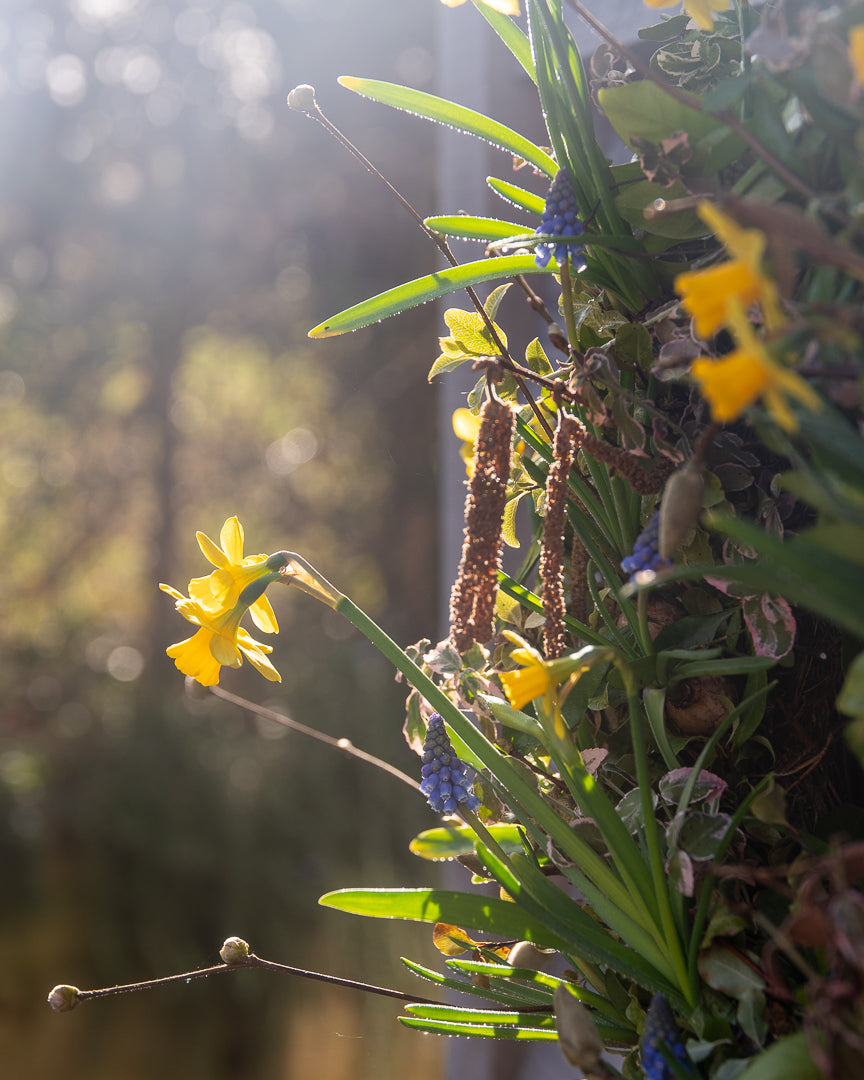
xmin=0 ymin=0 xmax=444 ymax=1080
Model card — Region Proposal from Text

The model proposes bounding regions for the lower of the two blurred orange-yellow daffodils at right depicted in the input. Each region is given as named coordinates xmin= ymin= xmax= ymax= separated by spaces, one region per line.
xmin=690 ymin=303 xmax=822 ymax=432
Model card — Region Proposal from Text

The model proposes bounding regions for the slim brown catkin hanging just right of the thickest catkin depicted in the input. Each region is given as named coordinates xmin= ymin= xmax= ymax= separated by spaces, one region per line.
xmin=540 ymin=416 xmax=582 ymax=660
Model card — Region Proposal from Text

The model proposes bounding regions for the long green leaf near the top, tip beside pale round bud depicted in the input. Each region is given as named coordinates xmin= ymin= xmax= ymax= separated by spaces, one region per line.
xmin=337 ymin=76 xmax=558 ymax=177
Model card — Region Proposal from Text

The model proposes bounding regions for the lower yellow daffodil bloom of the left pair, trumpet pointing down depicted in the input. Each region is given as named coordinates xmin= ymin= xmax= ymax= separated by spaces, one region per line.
xmin=159 ymin=585 xmax=282 ymax=686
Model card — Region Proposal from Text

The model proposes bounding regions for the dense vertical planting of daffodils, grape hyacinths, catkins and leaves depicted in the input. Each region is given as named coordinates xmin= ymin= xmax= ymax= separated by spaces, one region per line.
xmin=50 ymin=0 xmax=864 ymax=1080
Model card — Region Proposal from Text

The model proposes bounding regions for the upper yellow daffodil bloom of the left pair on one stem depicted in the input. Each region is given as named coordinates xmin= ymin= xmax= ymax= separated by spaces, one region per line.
xmin=189 ymin=517 xmax=279 ymax=634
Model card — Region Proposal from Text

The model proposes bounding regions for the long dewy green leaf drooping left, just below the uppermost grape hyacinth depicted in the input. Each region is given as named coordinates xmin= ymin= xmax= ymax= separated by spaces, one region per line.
xmin=309 ymin=255 xmax=540 ymax=338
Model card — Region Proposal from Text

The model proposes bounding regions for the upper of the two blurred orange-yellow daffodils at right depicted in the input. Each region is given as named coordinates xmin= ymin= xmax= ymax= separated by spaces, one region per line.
xmin=675 ymin=203 xmax=784 ymax=338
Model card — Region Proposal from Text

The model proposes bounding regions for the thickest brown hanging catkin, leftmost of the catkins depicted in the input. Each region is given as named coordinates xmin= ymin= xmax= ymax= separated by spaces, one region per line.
xmin=450 ymin=401 xmax=515 ymax=652
